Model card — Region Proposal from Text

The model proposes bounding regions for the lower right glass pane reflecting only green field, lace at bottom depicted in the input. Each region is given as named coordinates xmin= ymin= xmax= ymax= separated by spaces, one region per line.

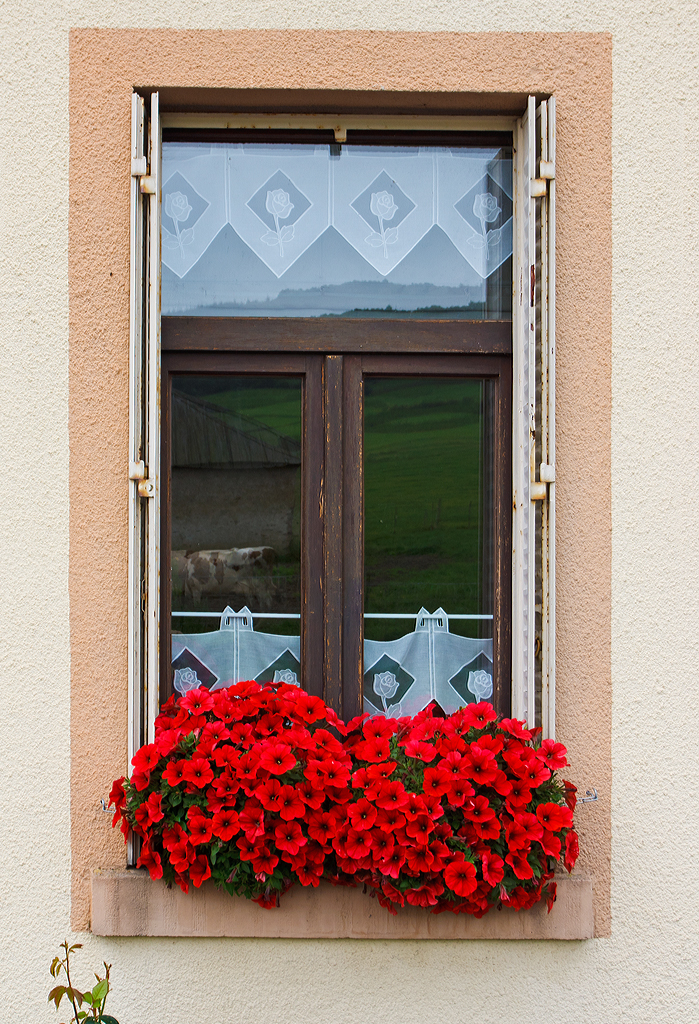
xmin=363 ymin=377 xmax=493 ymax=716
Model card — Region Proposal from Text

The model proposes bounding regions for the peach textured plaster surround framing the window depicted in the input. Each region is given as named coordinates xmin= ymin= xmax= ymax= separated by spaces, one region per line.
xmin=69 ymin=29 xmax=612 ymax=938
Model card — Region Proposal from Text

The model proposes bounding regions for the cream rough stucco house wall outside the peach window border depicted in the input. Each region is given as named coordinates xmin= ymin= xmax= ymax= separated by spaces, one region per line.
xmin=0 ymin=6 xmax=699 ymax=1024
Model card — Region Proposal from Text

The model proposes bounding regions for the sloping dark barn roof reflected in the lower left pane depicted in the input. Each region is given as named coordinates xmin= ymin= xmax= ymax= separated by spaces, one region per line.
xmin=172 ymin=389 xmax=301 ymax=469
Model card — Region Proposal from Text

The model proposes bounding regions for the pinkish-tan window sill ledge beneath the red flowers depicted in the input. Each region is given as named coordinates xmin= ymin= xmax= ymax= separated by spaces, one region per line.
xmin=91 ymin=869 xmax=595 ymax=939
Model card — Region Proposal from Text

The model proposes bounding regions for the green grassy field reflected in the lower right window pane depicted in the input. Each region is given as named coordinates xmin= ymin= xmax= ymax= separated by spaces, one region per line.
xmin=364 ymin=378 xmax=482 ymax=640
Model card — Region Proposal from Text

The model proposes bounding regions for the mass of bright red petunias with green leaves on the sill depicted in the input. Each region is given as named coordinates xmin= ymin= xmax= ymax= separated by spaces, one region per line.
xmin=111 ymin=682 xmax=578 ymax=916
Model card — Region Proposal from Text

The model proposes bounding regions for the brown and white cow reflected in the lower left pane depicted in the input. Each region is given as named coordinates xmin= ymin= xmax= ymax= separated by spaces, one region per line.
xmin=172 ymin=547 xmax=277 ymax=610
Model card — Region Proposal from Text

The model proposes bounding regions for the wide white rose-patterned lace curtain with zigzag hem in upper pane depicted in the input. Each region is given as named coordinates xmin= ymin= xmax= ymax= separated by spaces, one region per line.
xmin=162 ymin=142 xmax=513 ymax=279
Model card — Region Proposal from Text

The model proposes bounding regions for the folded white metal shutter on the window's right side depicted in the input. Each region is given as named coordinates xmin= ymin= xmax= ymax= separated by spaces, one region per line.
xmin=512 ymin=96 xmax=556 ymax=736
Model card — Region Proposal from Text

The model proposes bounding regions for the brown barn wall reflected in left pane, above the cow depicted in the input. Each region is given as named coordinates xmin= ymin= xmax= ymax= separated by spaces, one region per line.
xmin=172 ymin=466 xmax=301 ymax=557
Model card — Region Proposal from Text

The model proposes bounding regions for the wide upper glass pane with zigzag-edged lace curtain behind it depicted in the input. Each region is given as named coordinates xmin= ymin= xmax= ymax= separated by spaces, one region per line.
xmin=162 ymin=142 xmax=513 ymax=319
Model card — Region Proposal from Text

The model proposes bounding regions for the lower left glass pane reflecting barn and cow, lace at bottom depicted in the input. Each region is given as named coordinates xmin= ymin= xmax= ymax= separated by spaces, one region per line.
xmin=170 ymin=375 xmax=302 ymax=692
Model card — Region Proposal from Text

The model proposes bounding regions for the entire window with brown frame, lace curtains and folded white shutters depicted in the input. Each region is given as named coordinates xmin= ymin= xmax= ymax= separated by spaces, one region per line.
xmin=126 ymin=96 xmax=553 ymax=774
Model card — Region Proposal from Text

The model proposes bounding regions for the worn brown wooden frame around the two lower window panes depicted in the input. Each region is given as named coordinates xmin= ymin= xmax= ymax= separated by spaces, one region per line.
xmin=161 ymin=316 xmax=512 ymax=719
